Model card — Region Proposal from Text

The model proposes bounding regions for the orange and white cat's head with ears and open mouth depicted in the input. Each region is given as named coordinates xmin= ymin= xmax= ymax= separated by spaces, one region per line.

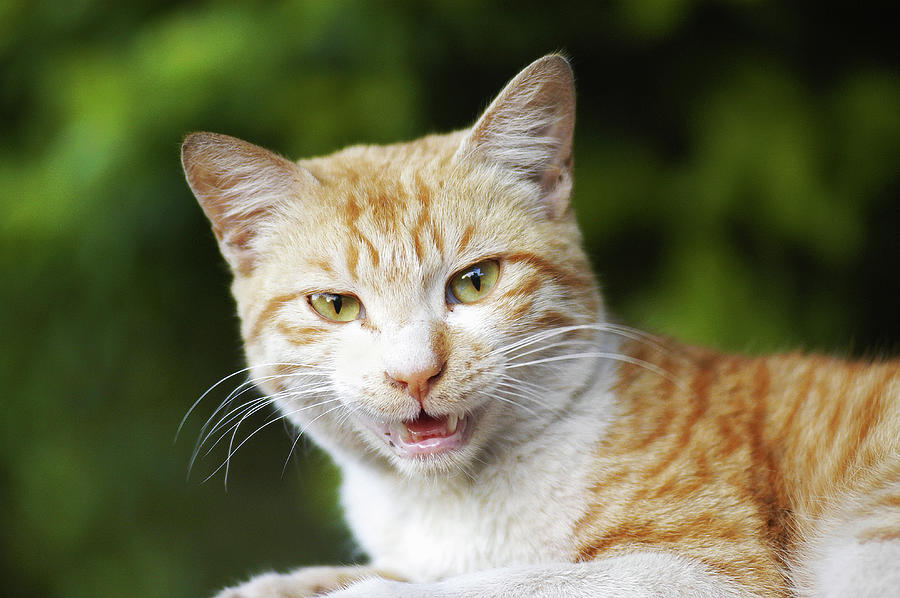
xmin=182 ymin=55 xmax=602 ymax=474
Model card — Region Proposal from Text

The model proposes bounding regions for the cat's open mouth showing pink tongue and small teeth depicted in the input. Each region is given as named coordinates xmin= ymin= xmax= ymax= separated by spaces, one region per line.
xmin=379 ymin=411 xmax=469 ymax=457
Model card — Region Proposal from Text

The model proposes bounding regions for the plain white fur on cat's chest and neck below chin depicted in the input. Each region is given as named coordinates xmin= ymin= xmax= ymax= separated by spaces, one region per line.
xmin=342 ymin=384 xmax=612 ymax=580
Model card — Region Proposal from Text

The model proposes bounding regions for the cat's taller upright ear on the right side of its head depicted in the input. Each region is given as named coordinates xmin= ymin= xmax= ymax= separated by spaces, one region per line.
xmin=457 ymin=54 xmax=575 ymax=218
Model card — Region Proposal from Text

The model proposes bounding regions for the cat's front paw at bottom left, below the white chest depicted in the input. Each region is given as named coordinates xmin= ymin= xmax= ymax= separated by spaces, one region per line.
xmin=215 ymin=567 xmax=386 ymax=598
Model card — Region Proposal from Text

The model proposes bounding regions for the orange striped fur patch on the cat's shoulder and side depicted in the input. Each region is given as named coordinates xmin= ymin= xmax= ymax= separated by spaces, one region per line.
xmin=576 ymin=338 xmax=900 ymax=596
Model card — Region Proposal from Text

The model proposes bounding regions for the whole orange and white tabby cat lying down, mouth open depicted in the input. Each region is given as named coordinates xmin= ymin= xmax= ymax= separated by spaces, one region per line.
xmin=182 ymin=55 xmax=900 ymax=598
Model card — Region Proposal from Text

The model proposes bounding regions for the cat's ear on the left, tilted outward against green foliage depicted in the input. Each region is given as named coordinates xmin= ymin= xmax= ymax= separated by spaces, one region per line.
xmin=181 ymin=133 xmax=318 ymax=274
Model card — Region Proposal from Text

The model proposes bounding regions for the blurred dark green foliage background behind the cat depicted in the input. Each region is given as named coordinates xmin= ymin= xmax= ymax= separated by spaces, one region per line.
xmin=0 ymin=0 xmax=900 ymax=598
